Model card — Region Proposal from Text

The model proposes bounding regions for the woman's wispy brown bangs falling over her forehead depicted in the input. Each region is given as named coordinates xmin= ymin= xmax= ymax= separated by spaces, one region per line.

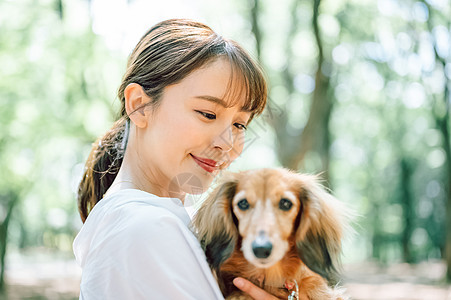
xmin=224 ymin=41 xmax=267 ymax=122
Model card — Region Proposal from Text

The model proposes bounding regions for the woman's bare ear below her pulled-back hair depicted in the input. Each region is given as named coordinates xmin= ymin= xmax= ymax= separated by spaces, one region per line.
xmin=124 ymin=83 xmax=151 ymax=128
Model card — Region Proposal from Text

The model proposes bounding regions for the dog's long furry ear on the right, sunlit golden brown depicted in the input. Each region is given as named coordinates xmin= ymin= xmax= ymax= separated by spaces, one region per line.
xmin=296 ymin=175 xmax=347 ymax=284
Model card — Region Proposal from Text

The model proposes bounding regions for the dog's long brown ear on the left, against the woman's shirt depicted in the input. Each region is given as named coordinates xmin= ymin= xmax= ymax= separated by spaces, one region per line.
xmin=193 ymin=176 xmax=238 ymax=270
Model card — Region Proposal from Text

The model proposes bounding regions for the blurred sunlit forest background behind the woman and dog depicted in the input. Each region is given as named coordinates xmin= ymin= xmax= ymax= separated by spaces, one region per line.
xmin=0 ymin=0 xmax=451 ymax=299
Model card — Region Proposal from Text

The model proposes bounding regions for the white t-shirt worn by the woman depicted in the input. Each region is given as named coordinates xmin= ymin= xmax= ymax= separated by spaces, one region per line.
xmin=73 ymin=189 xmax=224 ymax=300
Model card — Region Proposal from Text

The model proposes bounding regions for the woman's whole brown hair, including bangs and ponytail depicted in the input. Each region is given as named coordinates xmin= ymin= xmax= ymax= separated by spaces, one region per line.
xmin=78 ymin=19 xmax=267 ymax=222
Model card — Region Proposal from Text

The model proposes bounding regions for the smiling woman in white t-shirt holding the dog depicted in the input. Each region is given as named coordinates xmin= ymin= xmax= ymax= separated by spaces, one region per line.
xmin=74 ymin=20 xmax=272 ymax=300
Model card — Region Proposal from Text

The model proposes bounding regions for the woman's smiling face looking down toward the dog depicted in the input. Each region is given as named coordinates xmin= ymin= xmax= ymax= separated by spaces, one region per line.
xmin=137 ymin=59 xmax=251 ymax=197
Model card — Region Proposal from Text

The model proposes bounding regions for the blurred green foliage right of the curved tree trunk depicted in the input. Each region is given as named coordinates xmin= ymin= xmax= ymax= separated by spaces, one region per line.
xmin=331 ymin=1 xmax=451 ymax=268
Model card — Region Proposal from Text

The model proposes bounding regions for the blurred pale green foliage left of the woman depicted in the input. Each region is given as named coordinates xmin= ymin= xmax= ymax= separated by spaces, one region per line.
xmin=0 ymin=1 xmax=124 ymax=270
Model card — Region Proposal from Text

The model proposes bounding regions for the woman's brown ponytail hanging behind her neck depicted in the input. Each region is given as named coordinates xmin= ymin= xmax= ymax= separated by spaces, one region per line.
xmin=78 ymin=117 xmax=130 ymax=223
